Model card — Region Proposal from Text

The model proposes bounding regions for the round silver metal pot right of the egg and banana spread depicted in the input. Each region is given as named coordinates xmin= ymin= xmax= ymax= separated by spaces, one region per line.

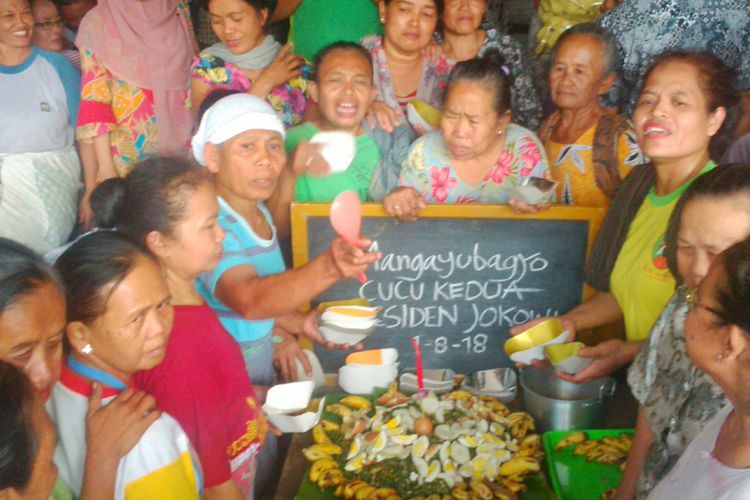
xmin=520 ymin=368 xmax=615 ymax=432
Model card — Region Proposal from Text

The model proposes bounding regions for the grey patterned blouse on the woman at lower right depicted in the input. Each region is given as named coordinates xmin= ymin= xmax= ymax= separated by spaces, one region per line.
xmin=628 ymin=287 xmax=727 ymax=498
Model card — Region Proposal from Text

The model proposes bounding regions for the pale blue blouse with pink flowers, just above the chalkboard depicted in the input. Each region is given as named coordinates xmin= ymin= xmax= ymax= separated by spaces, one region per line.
xmin=399 ymin=124 xmax=547 ymax=203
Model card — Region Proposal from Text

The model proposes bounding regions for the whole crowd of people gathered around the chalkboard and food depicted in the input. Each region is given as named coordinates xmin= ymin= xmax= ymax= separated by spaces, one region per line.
xmin=0 ymin=0 xmax=750 ymax=499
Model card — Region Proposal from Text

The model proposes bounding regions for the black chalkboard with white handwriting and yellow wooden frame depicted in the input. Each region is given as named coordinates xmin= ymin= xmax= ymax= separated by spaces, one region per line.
xmin=292 ymin=204 xmax=602 ymax=373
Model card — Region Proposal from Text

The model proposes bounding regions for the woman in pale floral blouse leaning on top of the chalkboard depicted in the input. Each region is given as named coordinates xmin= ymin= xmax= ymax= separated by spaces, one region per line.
xmin=383 ymin=52 xmax=547 ymax=220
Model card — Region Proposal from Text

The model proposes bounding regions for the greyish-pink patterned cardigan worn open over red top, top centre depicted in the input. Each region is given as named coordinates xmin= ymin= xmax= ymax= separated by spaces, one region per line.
xmin=359 ymin=35 xmax=453 ymax=108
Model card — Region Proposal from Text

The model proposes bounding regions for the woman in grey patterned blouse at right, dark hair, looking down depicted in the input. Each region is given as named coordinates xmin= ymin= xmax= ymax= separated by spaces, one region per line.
xmin=618 ymin=164 xmax=750 ymax=499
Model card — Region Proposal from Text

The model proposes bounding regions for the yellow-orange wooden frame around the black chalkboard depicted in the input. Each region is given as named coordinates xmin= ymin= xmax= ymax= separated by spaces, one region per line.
xmin=291 ymin=203 xmax=605 ymax=300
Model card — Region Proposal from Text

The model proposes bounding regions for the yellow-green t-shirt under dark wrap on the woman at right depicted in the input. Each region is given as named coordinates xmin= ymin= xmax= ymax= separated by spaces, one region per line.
xmin=610 ymin=162 xmax=715 ymax=341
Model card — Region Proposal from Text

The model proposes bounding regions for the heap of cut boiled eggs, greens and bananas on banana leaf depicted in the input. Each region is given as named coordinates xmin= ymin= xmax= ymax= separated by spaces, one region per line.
xmin=303 ymin=384 xmax=544 ymax=500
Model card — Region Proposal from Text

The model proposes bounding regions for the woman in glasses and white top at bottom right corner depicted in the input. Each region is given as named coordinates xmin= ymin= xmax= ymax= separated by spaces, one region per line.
xmin=648 ymin=240 xmax=750 ymax=500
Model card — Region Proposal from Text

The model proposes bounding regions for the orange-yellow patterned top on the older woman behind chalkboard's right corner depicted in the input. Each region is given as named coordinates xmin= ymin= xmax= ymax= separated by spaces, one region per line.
xmin=544 ymin=123 xmax=646 ymax=208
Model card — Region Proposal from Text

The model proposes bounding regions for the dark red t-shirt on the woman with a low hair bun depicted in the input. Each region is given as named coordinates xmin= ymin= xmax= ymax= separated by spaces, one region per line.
xmin=134 ymin=304 xmax=261 ymax=493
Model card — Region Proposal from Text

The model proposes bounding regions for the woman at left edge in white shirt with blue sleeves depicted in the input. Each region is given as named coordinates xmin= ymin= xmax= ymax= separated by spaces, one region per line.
xmin=0 ymin=0 xmax=81 ymax=253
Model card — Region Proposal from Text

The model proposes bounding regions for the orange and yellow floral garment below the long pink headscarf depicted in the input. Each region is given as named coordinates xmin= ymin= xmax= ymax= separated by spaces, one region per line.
xmin=76 ymin=50 xmax=159 ymax=177
